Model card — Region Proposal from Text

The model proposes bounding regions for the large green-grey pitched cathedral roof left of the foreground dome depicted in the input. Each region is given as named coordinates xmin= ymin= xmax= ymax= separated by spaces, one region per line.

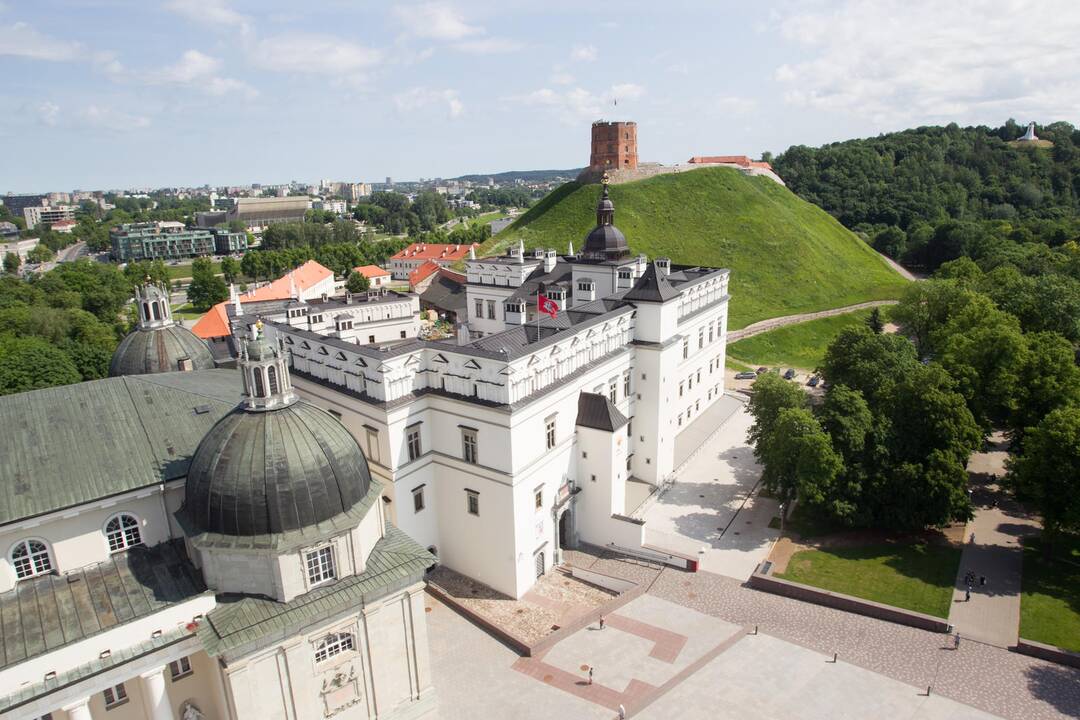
xmin=0 ymin=370 xmax=241 ymax=525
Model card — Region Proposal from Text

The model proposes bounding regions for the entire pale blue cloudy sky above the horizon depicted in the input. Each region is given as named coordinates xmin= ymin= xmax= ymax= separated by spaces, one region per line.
xmin=0 ymin=0 xmax=1080 ymax=193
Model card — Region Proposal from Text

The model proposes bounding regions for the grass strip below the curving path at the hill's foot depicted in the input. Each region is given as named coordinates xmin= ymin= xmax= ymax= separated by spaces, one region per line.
xmin=728 ymin=305 xmax=889 ymax=370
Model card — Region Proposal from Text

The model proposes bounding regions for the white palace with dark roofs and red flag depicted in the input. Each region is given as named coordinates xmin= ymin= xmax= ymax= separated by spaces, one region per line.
xmin=241 ymin=186 xmax=728 ymax=597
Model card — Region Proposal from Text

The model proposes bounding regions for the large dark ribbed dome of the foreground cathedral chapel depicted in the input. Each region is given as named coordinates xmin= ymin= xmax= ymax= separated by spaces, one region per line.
xmin=184 ymin=403 xmax=372 ymax=536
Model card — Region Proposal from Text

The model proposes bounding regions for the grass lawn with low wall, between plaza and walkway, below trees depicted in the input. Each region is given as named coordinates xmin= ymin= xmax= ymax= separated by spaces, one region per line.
xmin=777 ymin=543 xmax=960 ymax=617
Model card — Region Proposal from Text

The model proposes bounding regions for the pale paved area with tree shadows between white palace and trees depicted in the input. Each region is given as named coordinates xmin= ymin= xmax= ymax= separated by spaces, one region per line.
xmin=643 ymin=398 xmax=780 ymax=580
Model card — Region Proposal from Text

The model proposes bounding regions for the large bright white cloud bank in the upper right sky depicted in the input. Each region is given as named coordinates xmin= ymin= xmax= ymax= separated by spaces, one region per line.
xmin=775 ymin=0 xmax=1080 ymax=126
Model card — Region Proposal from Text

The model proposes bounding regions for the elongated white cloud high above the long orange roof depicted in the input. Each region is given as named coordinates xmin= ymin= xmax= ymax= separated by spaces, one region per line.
xmin=251 ymin=32 xmax=382 ymax=79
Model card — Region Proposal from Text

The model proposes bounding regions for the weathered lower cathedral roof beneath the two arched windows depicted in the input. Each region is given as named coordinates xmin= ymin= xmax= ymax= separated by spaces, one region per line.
xmin=0 ymin=540 xmax=206 ymax=668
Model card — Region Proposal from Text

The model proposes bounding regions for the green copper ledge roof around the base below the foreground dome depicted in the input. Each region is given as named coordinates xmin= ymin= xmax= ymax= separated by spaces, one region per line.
xmin=199 ymin=524 xmax=436 ymax=656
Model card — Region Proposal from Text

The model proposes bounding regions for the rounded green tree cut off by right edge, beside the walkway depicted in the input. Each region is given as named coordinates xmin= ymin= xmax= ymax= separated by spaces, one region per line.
xmin=1008 ymin=406 xmax=1080 ymax=542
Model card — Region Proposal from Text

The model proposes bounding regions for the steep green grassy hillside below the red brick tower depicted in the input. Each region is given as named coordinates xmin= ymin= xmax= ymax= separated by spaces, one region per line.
xmin=482 ymin=167 xmax=905 ymax=328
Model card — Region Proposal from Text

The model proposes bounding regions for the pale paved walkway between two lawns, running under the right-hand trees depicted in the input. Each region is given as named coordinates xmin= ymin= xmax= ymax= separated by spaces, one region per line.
xmin=948 ymin=433 xmax=1039 ymax=648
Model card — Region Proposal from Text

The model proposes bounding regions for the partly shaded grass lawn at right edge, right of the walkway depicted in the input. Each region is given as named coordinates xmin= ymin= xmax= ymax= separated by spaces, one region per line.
xmin=1020 ymin=535 xmax=1080 ymax=652
